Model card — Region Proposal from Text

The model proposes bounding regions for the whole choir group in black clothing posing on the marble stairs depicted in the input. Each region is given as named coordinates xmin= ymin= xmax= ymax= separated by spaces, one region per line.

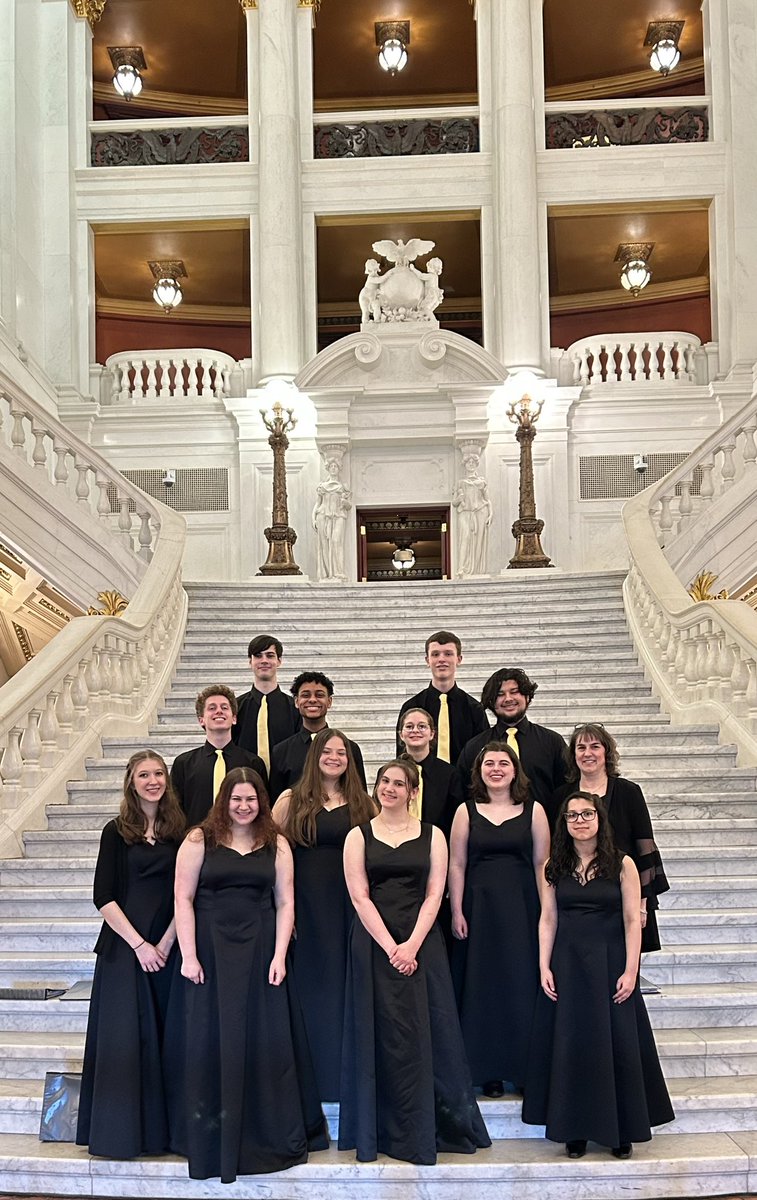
xmin=77 ymin=630 xmax=673 ymax=1182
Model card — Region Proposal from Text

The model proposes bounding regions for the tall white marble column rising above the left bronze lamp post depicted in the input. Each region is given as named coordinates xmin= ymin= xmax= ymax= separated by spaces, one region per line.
xmin=247 ymin=0 xmax=302 ymax=383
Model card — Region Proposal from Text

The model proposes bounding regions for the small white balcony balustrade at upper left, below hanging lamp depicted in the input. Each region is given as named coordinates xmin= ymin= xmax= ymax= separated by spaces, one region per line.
xmin=101 ymin=349 xmax=236 ymax=404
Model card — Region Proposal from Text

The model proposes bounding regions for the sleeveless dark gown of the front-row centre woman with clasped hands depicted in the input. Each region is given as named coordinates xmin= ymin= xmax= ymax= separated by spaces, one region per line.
xmin=340 ymin=822 xmax=491 ymax=1164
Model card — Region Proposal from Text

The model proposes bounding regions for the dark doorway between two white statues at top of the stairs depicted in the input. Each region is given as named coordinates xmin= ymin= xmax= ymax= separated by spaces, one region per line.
xmin=356 ymin=504 xmax=450 ymax=583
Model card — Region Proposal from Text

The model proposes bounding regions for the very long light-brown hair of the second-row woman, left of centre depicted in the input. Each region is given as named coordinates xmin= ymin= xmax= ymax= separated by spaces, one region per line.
xmin=281 ymin=726 xmax=376 ymax=846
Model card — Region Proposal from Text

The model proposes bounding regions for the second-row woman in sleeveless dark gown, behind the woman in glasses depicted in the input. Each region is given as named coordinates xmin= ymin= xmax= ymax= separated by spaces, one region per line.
xmin=450 ymin=742 xmax=549 ymax=1097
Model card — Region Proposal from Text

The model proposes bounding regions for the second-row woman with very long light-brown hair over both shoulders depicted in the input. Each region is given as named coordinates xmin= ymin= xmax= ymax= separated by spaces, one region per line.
xmin=274 ymin=728 xmax=376 ymax=1100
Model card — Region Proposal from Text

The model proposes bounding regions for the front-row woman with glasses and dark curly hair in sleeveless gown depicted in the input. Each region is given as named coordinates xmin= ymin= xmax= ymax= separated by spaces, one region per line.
xmin=523 ymin=791 xmax=674 ymax=1158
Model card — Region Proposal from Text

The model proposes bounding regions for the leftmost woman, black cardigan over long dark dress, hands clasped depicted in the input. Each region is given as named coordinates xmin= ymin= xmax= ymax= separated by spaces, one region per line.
xmin=77 ymin=750 xmax=184 ymax=1158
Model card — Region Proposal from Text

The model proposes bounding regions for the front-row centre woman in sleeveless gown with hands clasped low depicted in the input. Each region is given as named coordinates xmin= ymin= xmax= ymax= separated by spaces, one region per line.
xmin=340 ymin=761 xmax=491 ymax=1164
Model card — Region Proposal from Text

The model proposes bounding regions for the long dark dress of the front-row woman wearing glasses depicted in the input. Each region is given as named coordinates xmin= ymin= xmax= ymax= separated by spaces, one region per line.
xmin=523 ymin=877 xmax=674 ymax=1146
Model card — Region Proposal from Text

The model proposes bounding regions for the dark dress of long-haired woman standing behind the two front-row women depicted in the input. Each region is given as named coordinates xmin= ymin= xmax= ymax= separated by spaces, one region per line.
xmin=292 ymin=804 xmax=355 ymax=1100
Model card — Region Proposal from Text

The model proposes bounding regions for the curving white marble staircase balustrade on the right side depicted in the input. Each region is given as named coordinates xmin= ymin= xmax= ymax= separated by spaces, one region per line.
xmin=623 ymin=379 xmax=757 ymax=764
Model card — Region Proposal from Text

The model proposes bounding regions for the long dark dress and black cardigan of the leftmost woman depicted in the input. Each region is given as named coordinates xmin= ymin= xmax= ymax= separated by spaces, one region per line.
xmin=77 ymin=821 xmax=179 ymax=1158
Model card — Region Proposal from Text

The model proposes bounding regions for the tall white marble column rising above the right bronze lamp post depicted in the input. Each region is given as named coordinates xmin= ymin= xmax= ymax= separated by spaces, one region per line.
xmin=479 ymin=0 xmax=546 ymax=374
